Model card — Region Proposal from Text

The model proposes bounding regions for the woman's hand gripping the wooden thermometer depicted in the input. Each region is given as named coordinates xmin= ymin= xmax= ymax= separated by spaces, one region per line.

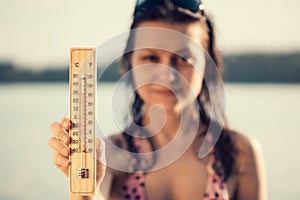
xmin=48 ymin=117 xmax=106 ymax=186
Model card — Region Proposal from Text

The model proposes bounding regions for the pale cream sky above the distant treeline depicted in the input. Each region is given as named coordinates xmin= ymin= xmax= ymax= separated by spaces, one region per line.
xmin=0 ymin=0 xmax=300 ymax=69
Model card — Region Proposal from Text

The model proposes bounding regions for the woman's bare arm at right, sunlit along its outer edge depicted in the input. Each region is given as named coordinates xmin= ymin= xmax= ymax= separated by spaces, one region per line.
xmin=236 ymin=133 xmax=267 ymax=200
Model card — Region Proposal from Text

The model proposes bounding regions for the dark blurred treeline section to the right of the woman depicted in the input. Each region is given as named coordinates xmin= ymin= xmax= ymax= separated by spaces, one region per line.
xmin=223 ymin=52 xmax=300 ymax=83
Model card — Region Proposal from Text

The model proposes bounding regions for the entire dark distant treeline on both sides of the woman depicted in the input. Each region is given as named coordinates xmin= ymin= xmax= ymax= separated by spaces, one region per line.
xmin=0 ymin=52 xmax=300 ymax=83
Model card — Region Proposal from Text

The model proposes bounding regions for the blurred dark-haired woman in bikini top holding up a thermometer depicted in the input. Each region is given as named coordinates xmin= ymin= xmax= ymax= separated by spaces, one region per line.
xmin=49 ymin=0 xmax=266 ymax=200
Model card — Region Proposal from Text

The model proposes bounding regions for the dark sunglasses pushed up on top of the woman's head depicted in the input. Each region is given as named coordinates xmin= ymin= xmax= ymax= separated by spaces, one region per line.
xmin=134 ymin=0 xmax=205 ymax=17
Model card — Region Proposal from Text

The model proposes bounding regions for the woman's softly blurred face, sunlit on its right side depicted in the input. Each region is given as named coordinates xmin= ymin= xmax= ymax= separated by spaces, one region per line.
xmin=130 ymin=21 xmax=207 ymax=111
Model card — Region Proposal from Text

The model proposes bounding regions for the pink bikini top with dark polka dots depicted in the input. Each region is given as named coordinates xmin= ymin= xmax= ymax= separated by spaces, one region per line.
xmin=122 ymin=135 xmax=229 ymax=200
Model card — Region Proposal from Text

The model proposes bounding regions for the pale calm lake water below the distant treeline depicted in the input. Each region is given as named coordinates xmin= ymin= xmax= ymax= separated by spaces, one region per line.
xmin=0 ymin=83 xmax=300 ymax=200
